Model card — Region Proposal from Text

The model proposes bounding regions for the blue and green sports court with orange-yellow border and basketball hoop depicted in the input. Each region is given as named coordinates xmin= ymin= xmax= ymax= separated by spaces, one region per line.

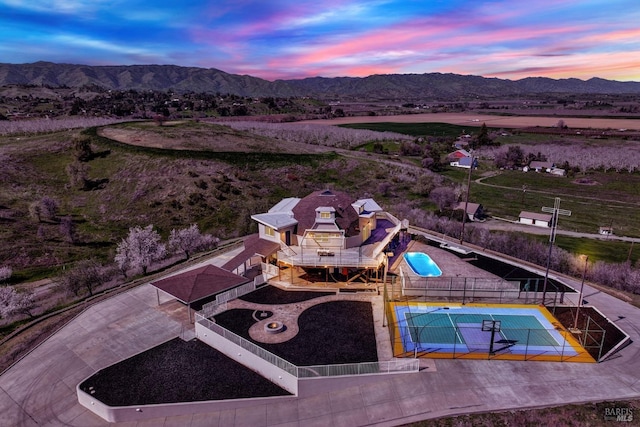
xmin=389 ymin=302 xmax=595 ymax=363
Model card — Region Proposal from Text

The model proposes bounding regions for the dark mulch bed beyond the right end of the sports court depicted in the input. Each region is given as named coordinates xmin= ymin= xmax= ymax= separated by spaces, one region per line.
xmin=549 ymin=307 xmax=625 ymax=360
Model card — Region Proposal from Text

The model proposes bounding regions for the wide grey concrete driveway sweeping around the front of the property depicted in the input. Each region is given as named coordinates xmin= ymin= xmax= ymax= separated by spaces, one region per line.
xmin=0 ymin=252 xmax=640 ymax=427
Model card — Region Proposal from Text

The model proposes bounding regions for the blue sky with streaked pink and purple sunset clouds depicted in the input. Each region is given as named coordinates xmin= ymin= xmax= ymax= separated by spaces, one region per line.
xmin=0 ymin=0 xmax=640 ymax=81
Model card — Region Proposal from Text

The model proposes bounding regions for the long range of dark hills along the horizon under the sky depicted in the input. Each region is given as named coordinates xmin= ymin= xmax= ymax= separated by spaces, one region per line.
xmin=0 ymin=62 xmax=640 ymax=100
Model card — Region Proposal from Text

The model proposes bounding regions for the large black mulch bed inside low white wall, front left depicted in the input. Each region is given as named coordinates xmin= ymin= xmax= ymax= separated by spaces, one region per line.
xmin=80 ymin=338 xmax=290 ymax=406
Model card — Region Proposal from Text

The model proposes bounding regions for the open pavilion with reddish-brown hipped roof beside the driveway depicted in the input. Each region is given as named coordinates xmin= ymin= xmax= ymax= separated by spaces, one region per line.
xmin=151 ymin=265 xmax=250 ymax=321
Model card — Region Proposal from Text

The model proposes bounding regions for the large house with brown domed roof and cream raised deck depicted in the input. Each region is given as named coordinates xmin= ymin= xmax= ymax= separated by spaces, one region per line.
xmin=251 ymin=190 xmax=403 ymax=282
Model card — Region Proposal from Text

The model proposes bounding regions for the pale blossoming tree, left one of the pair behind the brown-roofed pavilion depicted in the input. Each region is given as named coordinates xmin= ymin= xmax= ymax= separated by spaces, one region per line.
xmin=115 ymin=224 xmax=167 ymax=276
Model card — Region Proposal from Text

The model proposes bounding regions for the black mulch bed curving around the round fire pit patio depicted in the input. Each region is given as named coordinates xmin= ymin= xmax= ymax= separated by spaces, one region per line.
xmin=215 ymin=301 xmax=378 ymax=366
